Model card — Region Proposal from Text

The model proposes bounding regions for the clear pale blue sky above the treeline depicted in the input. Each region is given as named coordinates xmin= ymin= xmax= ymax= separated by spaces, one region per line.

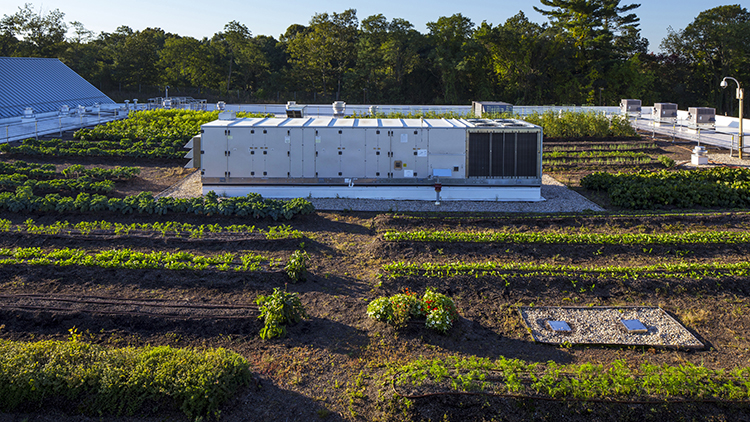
xmin=0 ymin=0 xmax=750 ymax=52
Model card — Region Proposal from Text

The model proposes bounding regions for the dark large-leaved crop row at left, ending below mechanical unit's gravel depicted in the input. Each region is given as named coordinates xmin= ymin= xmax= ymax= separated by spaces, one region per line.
xmin=0 ymin=186 xmax=315 ymax=220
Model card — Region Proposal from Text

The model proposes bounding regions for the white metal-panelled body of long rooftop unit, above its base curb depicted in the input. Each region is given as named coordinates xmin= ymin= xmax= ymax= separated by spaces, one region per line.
xmin=201 ymin=117 xmax=542 ymax=186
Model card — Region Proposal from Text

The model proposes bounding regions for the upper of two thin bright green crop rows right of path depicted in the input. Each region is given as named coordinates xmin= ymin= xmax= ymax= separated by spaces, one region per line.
xmin=383 ymin=231 xmax=750 ymax=245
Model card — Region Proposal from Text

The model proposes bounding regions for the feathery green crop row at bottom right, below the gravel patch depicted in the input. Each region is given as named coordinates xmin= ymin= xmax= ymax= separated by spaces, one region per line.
xmin=391 ymin=357 xmax=750 ymax=401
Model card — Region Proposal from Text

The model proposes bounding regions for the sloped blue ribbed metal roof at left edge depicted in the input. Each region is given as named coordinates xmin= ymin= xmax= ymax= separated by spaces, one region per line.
xmin=0 ymin=57 xmax=114 ymax=118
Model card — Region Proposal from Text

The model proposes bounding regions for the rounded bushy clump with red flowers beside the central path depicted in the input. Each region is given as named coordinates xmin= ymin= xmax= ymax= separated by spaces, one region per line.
xmin=367 ymin=288 xmax=458 ymax=333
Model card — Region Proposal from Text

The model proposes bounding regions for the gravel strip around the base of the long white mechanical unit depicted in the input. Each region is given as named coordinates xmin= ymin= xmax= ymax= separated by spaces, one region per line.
xmin=157 ymin=171 xmax=604 ymax=213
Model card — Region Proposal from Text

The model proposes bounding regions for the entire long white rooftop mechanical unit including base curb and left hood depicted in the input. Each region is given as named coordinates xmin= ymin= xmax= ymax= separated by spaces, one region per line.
xmin=186 ymin=117 xmax=543 ymax=201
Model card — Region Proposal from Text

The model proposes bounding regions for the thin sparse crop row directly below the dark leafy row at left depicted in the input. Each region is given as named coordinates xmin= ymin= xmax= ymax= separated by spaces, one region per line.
xmin=0 ymin=218 xmax=304 ymax=239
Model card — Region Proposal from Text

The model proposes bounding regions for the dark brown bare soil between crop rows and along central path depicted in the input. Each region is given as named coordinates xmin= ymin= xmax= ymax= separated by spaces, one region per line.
xmin=0 ymin=146 xmax=750 ymax=421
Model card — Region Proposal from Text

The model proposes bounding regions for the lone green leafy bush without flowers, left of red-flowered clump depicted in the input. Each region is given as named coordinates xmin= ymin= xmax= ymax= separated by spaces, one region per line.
xmin=255 ymin=288 xmax=307 ymax=340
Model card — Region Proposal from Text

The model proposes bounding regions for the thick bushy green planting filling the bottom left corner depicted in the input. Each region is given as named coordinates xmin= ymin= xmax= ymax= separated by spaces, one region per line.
xmin=0 ymin=338 xmax=252 ymax=419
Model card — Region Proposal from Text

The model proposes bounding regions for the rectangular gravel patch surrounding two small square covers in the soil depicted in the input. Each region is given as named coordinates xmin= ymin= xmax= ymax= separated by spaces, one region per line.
xmin=519 ymin=307 xmax=703 ymax=348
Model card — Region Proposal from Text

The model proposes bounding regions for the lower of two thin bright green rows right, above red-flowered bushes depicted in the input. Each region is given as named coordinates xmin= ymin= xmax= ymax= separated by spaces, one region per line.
xmin=381 ymin=261 xmax=750 ymax=280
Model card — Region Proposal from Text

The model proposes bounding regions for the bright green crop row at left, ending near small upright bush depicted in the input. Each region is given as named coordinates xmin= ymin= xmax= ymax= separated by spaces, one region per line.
xmin=0 ymin=247 xmax=281 ymax=271
